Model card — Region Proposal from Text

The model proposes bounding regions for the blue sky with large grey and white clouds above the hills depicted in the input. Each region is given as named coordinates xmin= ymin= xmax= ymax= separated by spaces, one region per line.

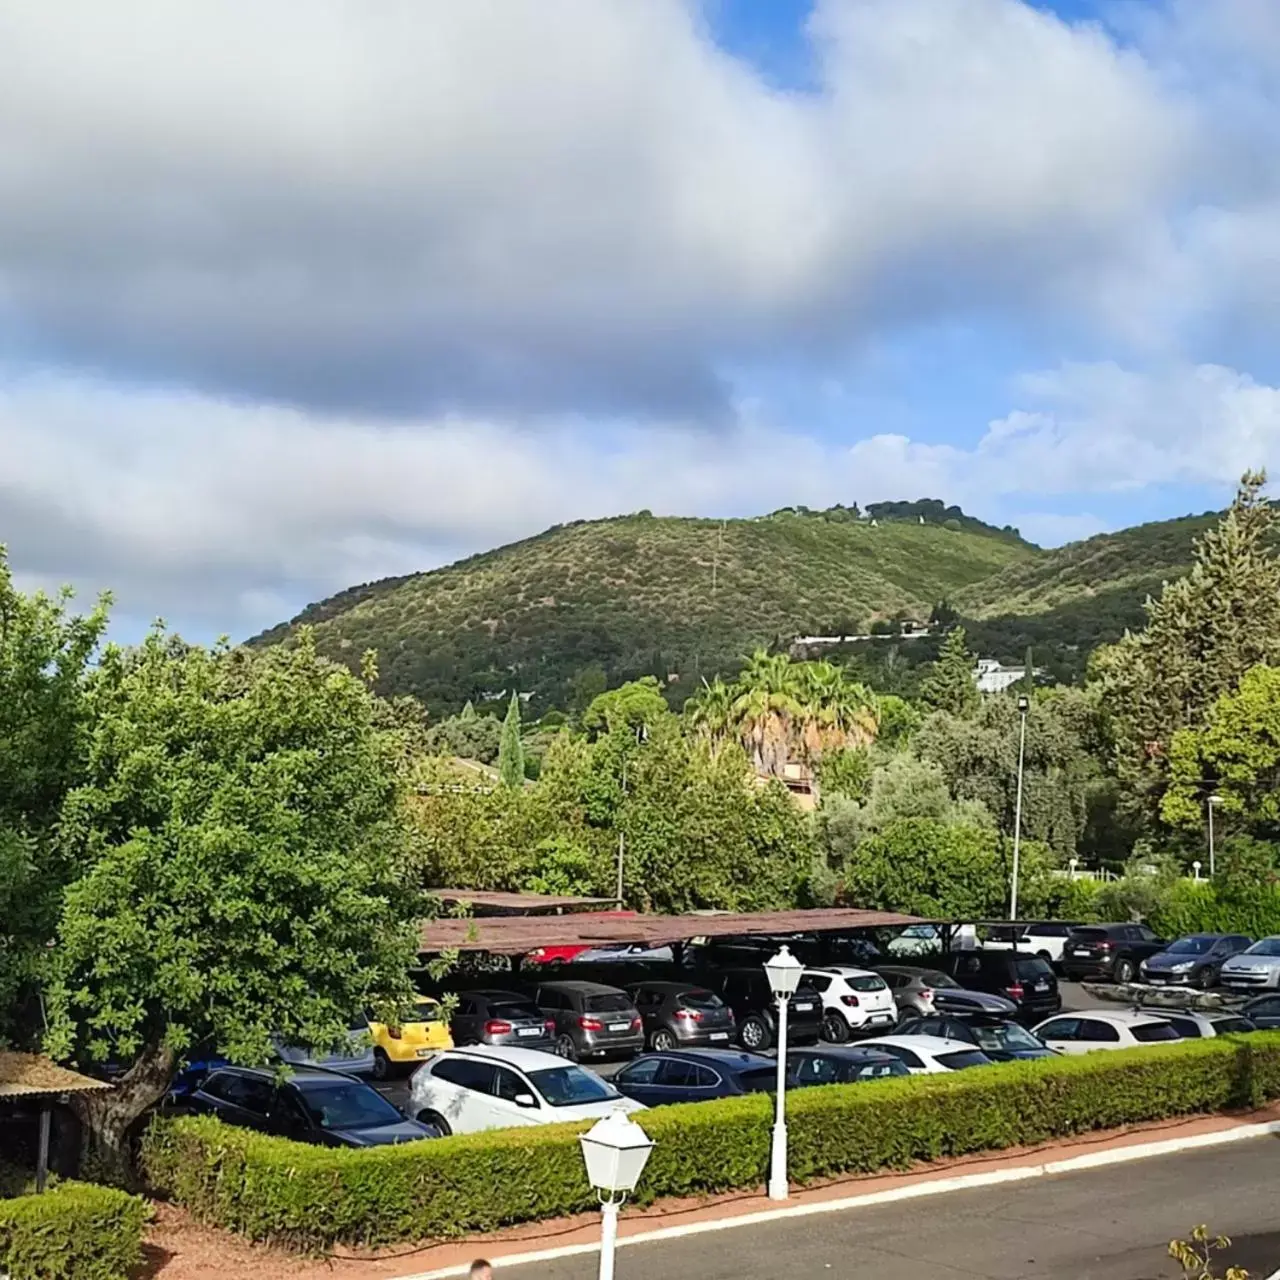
xmin=0 ymin=0 xmax=1280 ymax=640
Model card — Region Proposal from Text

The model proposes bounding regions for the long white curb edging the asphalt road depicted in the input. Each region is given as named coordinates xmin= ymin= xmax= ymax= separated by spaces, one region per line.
xmin=397 ymin=1120 xmax=1280 ymax=1280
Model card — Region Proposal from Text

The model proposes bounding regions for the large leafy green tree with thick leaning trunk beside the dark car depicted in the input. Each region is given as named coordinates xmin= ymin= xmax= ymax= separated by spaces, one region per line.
xmin=45 ymin=631 xmax=421 ymax=1175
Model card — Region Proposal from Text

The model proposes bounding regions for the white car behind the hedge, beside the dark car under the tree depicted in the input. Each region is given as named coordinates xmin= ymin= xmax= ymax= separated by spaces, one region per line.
xmin=408 ymin=1044 xmax=644 ymax=1134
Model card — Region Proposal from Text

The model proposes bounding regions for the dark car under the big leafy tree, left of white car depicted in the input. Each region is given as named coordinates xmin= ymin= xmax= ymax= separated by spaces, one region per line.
xmin=187 ymin=1066 xmax=440 ymax=1147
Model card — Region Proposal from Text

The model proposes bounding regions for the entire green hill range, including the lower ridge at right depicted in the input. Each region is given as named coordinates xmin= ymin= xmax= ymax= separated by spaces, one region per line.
xmin=253 ymin=500 xmax=1215 ymax=718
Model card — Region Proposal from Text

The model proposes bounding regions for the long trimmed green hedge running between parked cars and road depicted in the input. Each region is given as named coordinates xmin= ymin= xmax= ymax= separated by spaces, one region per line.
xmin=143 ymin=1032 xmax=1280 ymax=1249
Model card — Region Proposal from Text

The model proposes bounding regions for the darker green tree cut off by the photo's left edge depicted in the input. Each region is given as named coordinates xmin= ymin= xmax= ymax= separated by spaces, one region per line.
xmin=0 ymin=547 xmax=106 ymax=1041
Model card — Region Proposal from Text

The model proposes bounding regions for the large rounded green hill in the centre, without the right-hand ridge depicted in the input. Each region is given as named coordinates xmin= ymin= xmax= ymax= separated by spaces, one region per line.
xmin=256 ymin=503 xmax=1044 ymax=717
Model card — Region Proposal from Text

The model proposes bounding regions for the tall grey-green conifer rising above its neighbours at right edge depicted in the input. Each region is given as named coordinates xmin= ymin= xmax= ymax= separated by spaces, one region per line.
xmin=1092 ymin=471 xmax=1280 ymax=817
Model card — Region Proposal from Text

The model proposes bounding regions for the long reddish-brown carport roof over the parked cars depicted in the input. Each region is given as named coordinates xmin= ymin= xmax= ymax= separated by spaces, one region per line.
xmin=421 ymin=906 xmax=929 ymax=955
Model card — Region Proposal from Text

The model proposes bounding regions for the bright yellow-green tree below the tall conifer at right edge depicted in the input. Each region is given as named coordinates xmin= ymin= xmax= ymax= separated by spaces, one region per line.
xmin=1160 ymin=666 xmax=1280 ymax=836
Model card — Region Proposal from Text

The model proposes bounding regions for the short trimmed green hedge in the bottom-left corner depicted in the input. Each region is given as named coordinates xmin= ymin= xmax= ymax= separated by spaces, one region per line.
xmin=0 ymin=1183 xmax=150 ymax=1280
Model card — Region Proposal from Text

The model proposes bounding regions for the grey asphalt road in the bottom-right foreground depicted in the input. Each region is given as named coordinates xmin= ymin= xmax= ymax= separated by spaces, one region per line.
xmin=502 ymin=1138 xmax=1280 ymax=1280
